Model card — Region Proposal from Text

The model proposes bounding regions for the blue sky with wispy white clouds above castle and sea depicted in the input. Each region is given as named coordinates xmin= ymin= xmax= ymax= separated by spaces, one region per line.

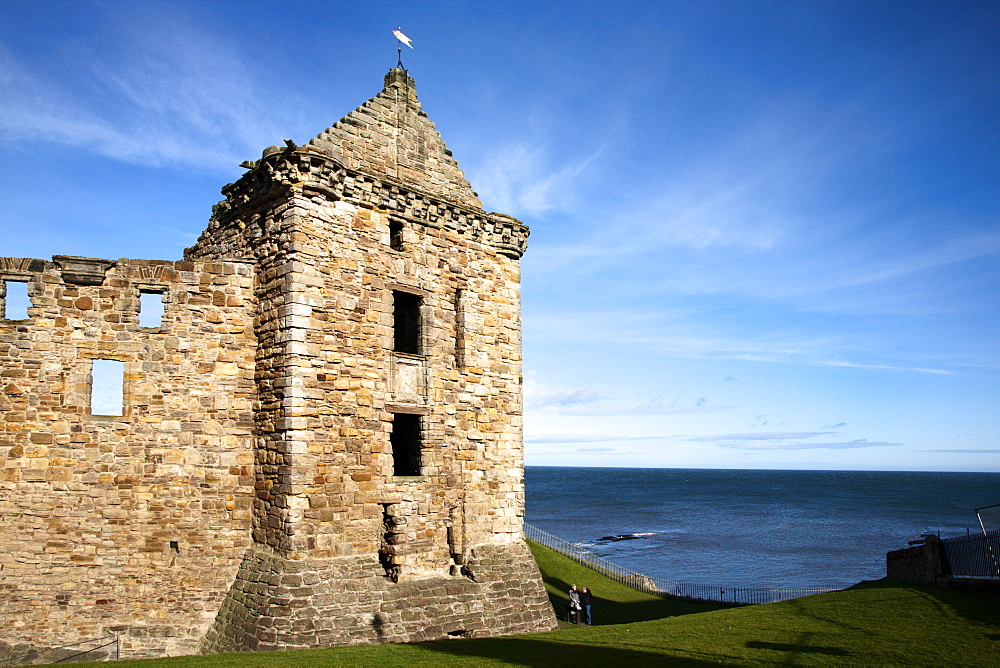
xmin=0 ymin=0 xmax=1000 ymax=471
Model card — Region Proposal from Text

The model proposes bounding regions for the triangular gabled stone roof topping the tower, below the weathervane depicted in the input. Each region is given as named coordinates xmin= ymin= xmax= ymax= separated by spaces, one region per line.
xmin=309 ymin=68 xmax=482 ymax=209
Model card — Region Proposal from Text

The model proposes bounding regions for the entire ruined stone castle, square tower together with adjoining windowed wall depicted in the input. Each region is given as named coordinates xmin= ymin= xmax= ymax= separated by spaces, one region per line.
xmin=0 ymin=68 xmax=555 ymax=658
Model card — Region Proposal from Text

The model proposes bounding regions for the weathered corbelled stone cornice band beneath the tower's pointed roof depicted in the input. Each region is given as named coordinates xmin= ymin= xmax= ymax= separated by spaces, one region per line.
xmin=209 ymin=146 xmax=529 ymax=259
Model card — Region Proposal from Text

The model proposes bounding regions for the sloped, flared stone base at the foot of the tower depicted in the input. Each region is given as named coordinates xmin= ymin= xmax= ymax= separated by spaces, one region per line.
xmin=195 ymin=541 xmax=557 ymax=654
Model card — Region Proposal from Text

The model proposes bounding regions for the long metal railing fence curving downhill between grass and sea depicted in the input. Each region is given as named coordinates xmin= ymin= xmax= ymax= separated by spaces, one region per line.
xmin=524 ymin=522 xmax=840 ymax=605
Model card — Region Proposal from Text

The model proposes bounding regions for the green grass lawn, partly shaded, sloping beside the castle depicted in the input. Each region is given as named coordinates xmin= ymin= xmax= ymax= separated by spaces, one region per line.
xmin=80 ymin=545 xmax=1000 ymax=666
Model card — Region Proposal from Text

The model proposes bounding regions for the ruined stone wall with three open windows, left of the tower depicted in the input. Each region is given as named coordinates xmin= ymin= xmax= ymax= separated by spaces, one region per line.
xmin=0 ymin=256 xmax=256 ymax=656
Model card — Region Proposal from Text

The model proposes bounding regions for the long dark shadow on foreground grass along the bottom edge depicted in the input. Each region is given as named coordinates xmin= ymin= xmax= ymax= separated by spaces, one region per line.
xmin=414 ymin=637 xmax=724 ymax=666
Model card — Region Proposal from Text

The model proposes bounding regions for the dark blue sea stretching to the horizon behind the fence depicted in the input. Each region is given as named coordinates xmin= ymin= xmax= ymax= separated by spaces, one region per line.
xmin=525 ymin=466 xmax=1000 ymax=588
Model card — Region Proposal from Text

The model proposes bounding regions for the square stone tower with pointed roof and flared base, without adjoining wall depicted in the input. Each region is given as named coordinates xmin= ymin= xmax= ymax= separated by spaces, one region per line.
xmin=186 ymin=69 xmax=553 ymax=650
